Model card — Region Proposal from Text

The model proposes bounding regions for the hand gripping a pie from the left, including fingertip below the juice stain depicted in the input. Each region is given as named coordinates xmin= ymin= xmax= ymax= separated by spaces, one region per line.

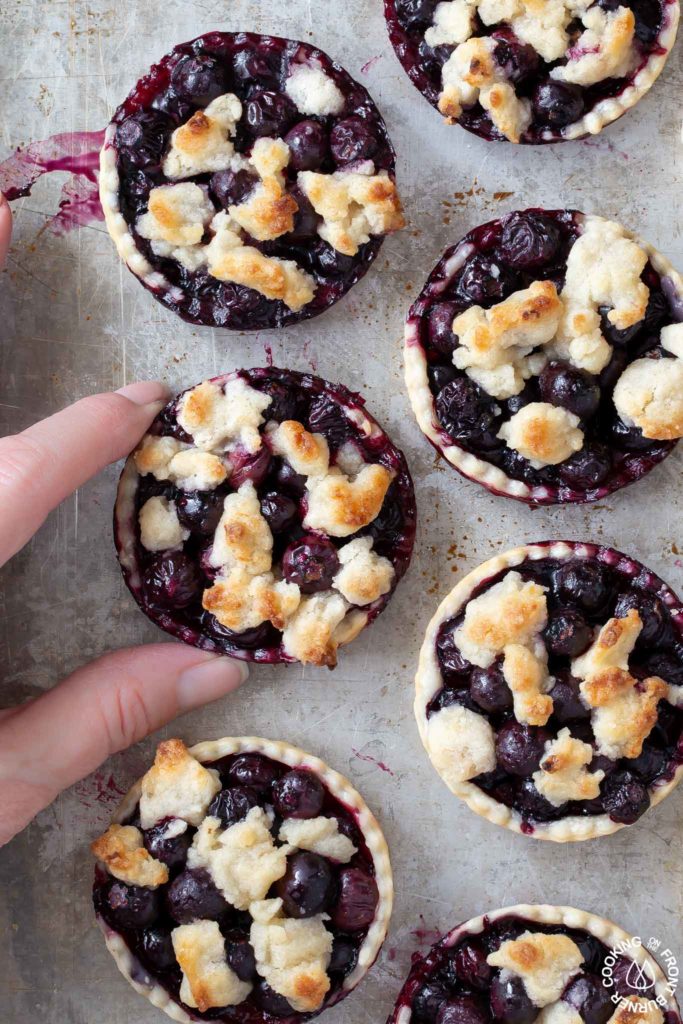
xmin=0 ymin=196 xmax=248 ymax=845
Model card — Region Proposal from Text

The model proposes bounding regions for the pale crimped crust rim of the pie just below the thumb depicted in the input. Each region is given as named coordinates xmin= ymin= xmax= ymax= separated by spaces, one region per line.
xmin=97 ymin=736 xmax=393 ymax=1024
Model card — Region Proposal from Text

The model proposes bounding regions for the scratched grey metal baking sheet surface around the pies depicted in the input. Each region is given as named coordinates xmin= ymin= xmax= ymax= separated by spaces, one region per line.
xmin=0 ymin=0 xmax=683 ymax=1024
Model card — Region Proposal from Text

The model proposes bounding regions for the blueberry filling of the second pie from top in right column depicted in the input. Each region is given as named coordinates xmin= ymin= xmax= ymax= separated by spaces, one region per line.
xmin=409 ymin=210 xmax=680 ymax=504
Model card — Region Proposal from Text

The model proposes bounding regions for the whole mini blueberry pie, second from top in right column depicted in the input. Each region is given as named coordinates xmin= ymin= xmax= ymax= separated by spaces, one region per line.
xmin=405 ymin=210 xmax=683 ymax=505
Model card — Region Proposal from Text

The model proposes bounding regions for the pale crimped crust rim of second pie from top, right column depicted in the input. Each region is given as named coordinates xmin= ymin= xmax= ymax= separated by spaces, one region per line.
xmin=403 ymin=213 xmax=683 ymax=505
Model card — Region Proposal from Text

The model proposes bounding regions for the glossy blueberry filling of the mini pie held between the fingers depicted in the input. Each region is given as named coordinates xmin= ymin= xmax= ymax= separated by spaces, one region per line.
xmin=116 ymin=368 xmax=416 ymax=663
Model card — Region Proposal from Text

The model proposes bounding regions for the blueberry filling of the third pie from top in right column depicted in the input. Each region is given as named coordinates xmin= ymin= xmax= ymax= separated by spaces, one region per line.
xmin=427 ymin=549 xmax=683 ymax=833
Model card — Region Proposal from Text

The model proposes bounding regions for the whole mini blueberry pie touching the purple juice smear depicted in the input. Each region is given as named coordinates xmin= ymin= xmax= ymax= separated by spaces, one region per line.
xmin=100 ymin=32 xmax=403 ymax=331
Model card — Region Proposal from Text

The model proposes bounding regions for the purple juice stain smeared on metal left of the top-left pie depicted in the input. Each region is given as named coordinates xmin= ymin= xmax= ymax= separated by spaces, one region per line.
xmin=0 ymin=129 xmax=104 ymax=234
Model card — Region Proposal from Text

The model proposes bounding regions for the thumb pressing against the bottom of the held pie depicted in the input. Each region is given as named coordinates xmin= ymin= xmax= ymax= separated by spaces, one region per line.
xmin=0 ymin=644 xmax=249 ymax=845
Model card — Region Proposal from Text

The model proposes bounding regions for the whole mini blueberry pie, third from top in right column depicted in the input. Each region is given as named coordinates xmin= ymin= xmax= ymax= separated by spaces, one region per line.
xmin=415 ymin=542 xmax=683 ymax=842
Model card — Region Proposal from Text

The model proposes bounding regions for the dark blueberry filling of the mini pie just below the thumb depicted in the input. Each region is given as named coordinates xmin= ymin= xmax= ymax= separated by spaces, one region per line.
xmin=93 ymin=754 xmax=379 ymax=1024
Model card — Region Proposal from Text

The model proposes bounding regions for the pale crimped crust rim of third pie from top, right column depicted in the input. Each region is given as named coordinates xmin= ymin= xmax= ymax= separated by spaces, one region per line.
xmin=414 ymin=541 xmax=683 ymax=843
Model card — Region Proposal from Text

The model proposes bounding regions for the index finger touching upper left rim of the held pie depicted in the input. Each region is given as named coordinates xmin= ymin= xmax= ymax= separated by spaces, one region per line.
xmin=0 ymin=381 xmax=168 ymax=564
